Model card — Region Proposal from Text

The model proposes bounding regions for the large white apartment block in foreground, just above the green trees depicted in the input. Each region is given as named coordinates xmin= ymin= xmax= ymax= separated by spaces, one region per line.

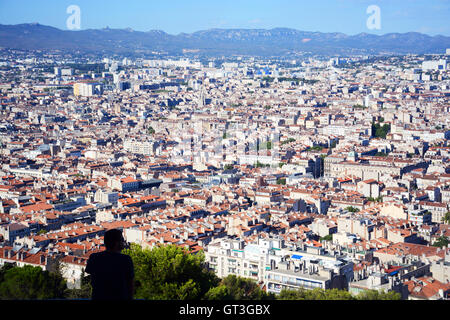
xmin=205 ymin=239 xmax=353 ymax=293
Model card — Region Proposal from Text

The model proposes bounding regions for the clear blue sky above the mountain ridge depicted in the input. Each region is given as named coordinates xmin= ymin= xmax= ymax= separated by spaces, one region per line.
xmin=0 ymin=0 xmax=450 ymax=36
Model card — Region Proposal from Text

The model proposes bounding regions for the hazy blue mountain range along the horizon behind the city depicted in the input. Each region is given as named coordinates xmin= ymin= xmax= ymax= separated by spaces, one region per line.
xmin=0 ymin=23 xmax=450 ymax=56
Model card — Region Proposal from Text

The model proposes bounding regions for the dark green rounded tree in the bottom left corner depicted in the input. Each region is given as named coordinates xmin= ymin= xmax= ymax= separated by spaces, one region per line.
xmin=0 ymin=265 xmax=67 ymax=300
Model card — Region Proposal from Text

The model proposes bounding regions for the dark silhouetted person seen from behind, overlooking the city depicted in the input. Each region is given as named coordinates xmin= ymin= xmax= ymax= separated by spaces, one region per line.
xmin=86 ymin=229 xmax=134 ymax=300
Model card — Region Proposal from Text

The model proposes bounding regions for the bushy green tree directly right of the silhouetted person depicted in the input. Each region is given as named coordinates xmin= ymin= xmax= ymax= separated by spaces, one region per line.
xmin=124 ymin=244 xmax=219 ymax=300
